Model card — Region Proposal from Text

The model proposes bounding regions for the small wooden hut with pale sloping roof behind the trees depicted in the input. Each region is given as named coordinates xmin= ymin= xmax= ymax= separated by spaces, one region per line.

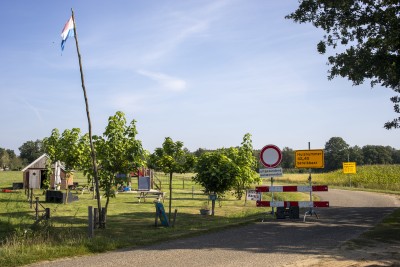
xmin=22 ymin=154 xmax=74 ymax=189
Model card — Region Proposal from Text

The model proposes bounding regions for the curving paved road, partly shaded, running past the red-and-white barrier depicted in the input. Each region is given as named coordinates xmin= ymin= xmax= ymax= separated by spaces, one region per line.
xmin=31 ymin=190 xmax=400 ymax=267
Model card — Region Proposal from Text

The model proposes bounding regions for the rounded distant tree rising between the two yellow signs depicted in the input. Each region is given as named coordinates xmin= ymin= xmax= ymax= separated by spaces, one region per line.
xmin=324 ymin=137 xmax=349 ymax=171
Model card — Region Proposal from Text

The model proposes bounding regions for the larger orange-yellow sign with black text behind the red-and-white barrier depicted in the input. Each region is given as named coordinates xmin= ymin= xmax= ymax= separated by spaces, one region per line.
xmin=295 ymin=149 xmax=325 ymax=169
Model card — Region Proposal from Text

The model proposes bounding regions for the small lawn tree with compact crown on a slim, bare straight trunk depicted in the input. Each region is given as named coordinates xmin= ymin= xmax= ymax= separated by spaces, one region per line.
xmin=151 ymin=137 xmax=195 ymax=224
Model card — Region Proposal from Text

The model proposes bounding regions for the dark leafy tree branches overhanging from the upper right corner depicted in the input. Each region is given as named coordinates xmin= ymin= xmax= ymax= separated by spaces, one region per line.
xmin=286 ymin=0 xmax=400 ymax=129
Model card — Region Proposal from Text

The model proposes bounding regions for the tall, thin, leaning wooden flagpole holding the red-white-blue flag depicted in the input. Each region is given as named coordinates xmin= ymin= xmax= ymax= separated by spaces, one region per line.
xmin=71 ymin=8 xmax=103 ymax=225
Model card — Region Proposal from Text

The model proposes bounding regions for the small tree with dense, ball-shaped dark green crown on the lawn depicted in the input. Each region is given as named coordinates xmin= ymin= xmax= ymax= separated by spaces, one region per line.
xmin=193 ymin=150 xmax=239 ymax=217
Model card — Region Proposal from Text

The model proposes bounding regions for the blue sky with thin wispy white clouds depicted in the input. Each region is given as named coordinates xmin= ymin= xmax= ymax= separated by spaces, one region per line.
xmin=0 ymin=0 xmax=400 ymax=154
